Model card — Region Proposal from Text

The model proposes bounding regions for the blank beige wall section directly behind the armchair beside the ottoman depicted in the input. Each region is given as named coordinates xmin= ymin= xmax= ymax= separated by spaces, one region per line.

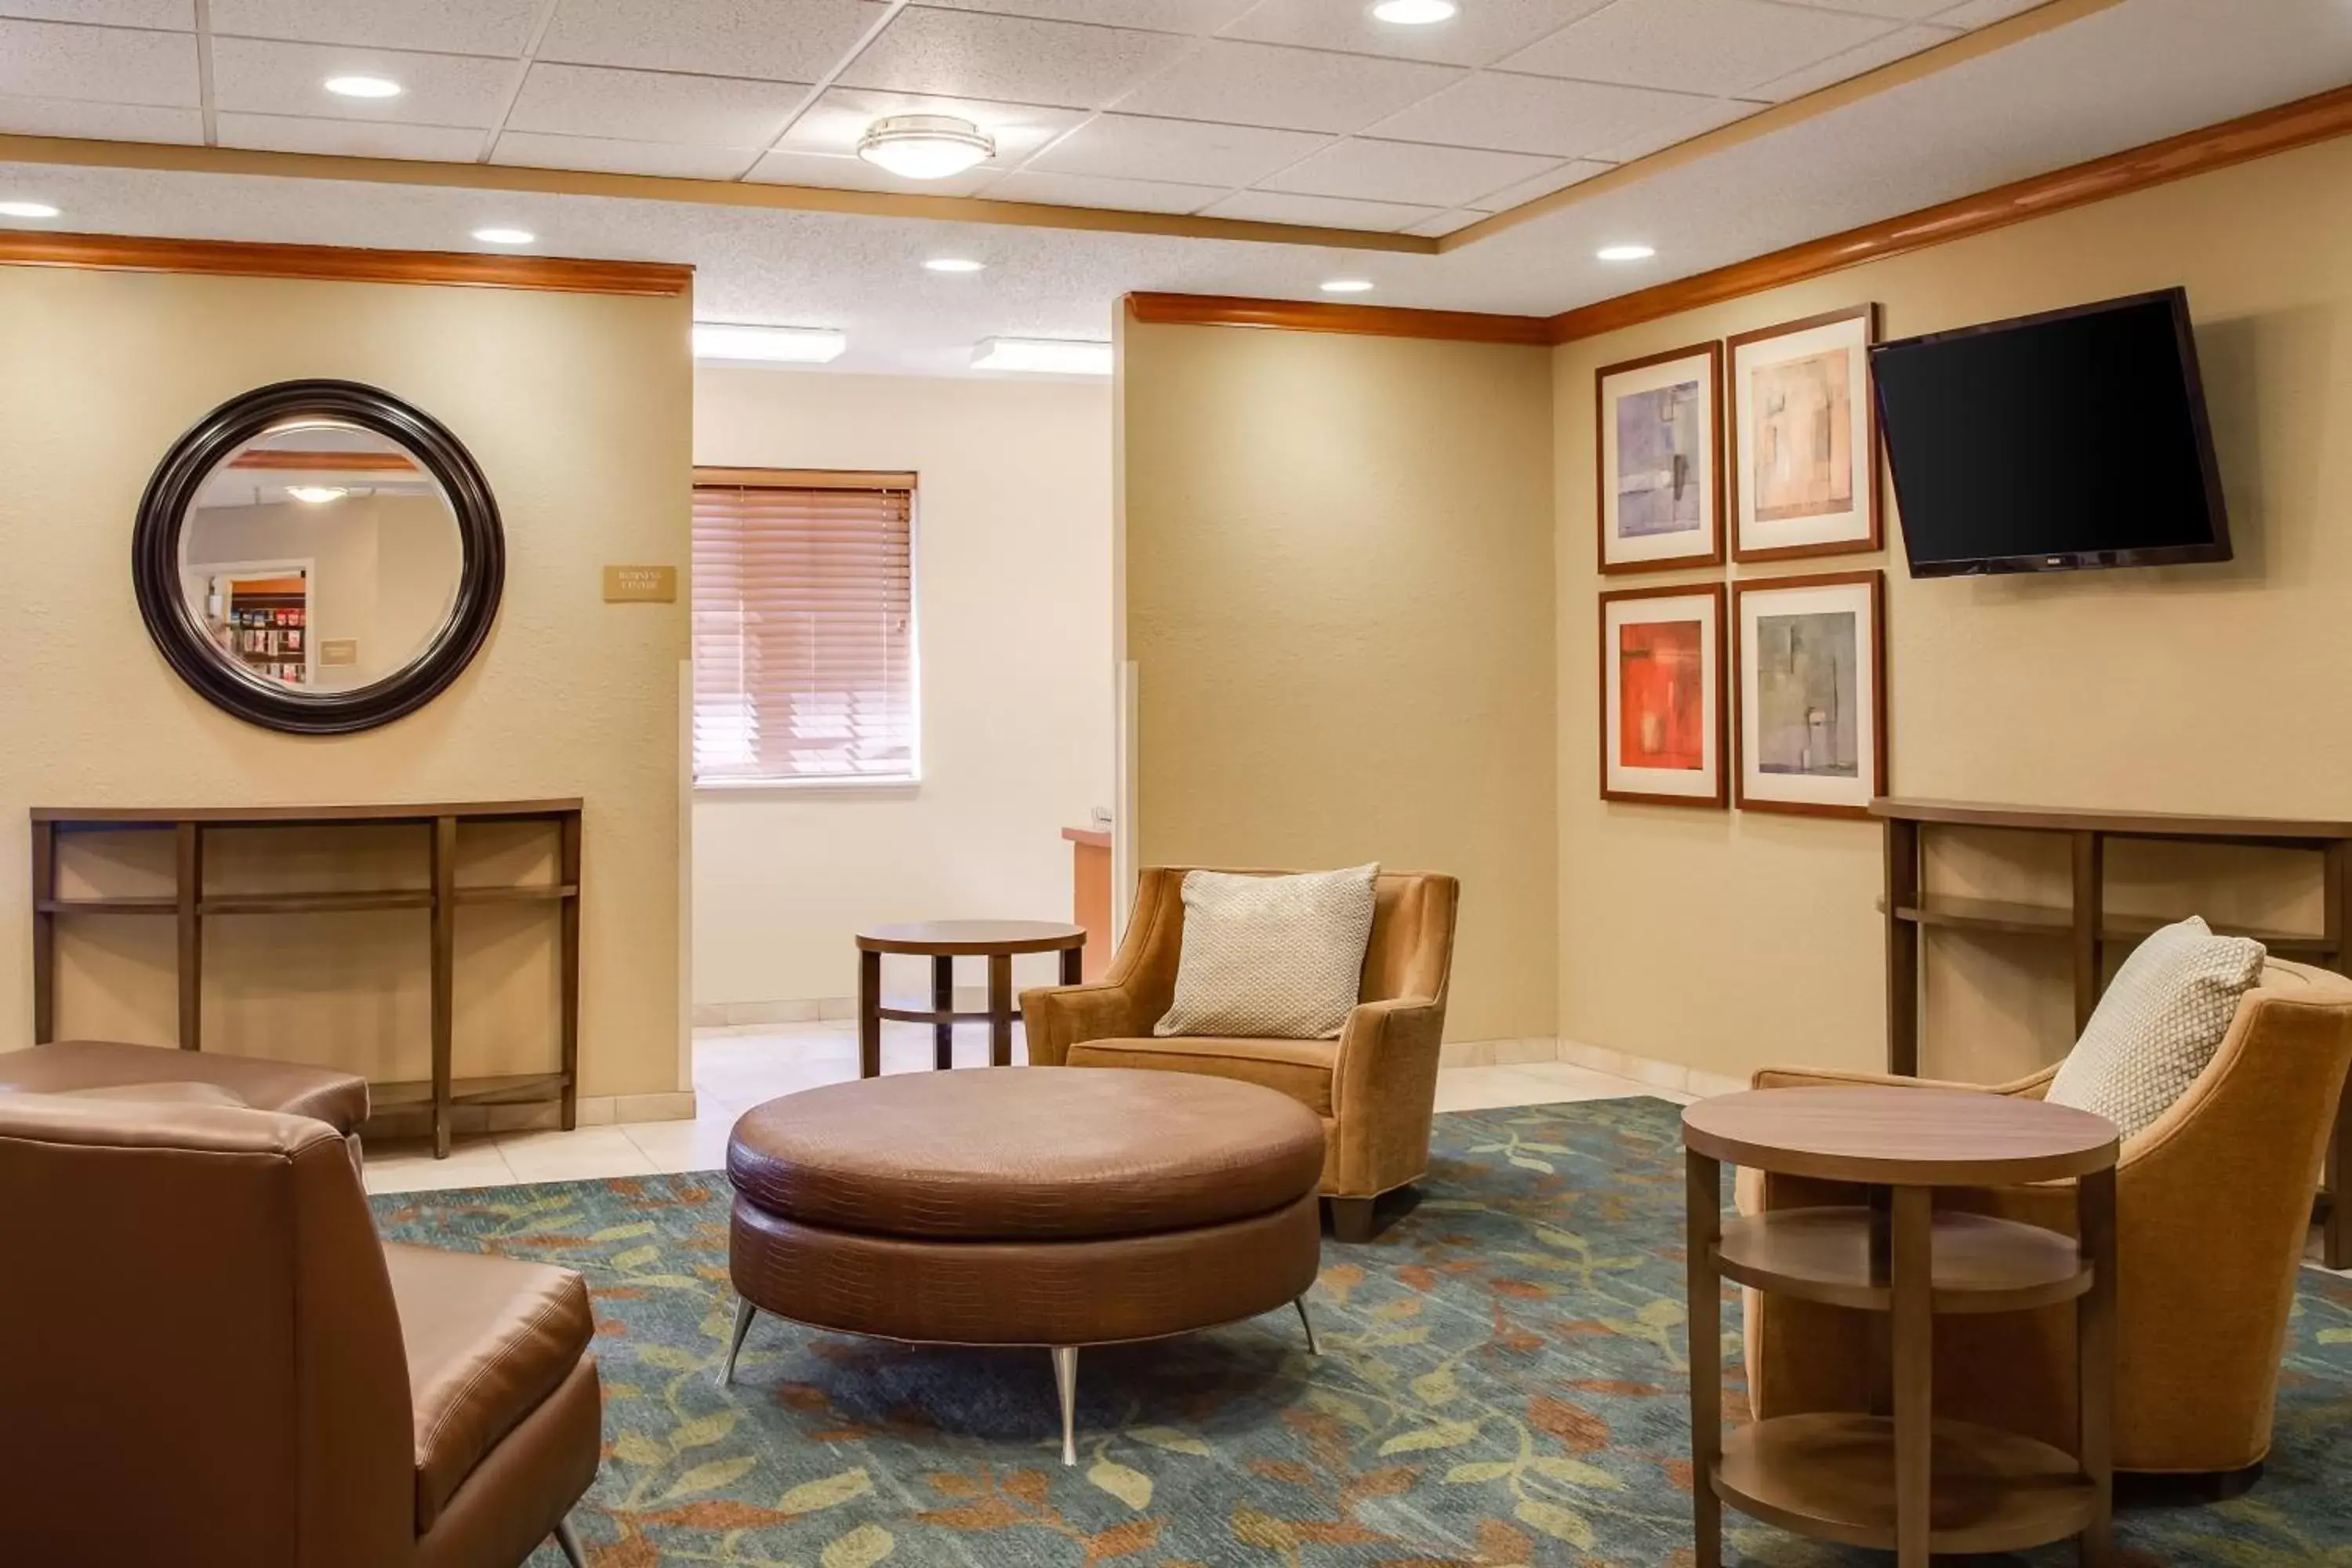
xmin=1120 ymin=322 xmax=1557 ymax=1039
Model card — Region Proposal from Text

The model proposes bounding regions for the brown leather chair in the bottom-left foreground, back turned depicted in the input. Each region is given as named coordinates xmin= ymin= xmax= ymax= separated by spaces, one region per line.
xmin=0 ymin=1093 xmax=602 ymax=1568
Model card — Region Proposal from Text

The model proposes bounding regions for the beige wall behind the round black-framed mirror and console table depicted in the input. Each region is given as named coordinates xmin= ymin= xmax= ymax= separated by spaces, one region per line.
xmin=0 ymin=268 xmax=691 ymax=1095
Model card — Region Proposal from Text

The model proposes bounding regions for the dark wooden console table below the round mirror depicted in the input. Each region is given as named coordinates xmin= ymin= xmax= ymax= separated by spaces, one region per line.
xmin=33 ymin=799 xmax=581 ymax=1156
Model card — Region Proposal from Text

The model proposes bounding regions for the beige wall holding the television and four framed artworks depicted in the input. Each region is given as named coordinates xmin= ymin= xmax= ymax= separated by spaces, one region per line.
xmin=1555 ymin=141 xmax=2352 ymax=1079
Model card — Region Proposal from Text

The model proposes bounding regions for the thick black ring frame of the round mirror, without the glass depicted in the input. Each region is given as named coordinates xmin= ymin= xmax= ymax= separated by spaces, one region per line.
xmin=132 ymin=381 xmax=506 ymax=736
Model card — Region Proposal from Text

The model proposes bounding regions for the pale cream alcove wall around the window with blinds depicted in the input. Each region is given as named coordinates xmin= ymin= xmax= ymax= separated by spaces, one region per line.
xmin=694 ymin=367 xmax=1112 ymax=1008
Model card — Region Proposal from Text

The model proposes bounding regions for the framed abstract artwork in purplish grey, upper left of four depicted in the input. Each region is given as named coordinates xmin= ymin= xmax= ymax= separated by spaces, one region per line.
xmin=1592 ymin=343 xmax=1724 ymax=572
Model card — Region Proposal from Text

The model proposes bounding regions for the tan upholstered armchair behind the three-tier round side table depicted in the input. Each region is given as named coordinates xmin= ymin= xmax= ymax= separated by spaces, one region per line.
xmin=1738 ymin=959 xmax=2352 ymax=1474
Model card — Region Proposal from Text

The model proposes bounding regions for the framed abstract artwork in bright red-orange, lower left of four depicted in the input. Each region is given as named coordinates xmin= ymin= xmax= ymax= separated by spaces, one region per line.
xmin=1599 ymin=583 xmax=1729 ymax=806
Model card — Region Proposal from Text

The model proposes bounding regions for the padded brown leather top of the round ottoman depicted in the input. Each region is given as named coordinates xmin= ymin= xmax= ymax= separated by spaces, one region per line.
xmin=727 ymin=1067 xmax=1324 ymax=1241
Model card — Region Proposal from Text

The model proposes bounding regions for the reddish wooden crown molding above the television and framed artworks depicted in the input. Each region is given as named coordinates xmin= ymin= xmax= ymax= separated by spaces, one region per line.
xmin=1550 ymin=87 xmax=2352 ymax=343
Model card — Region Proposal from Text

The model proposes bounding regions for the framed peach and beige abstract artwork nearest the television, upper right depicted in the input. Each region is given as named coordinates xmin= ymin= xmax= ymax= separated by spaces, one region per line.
xmin=1726 ymin=306 xmax=1879 ymax=562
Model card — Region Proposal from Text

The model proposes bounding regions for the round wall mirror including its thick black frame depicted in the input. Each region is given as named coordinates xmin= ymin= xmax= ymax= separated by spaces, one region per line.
xmin=132 ymin=381 xmax=506 ymax=734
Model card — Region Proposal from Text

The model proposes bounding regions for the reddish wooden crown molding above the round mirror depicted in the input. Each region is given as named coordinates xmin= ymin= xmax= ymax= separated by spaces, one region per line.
xmin=0 ymin=230 xmax=694 ymax=299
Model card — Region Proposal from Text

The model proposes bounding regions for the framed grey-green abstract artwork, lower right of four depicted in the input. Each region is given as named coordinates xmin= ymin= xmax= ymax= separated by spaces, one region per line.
xmin=1731 ymin=572 xmax=1886 ymax=815
